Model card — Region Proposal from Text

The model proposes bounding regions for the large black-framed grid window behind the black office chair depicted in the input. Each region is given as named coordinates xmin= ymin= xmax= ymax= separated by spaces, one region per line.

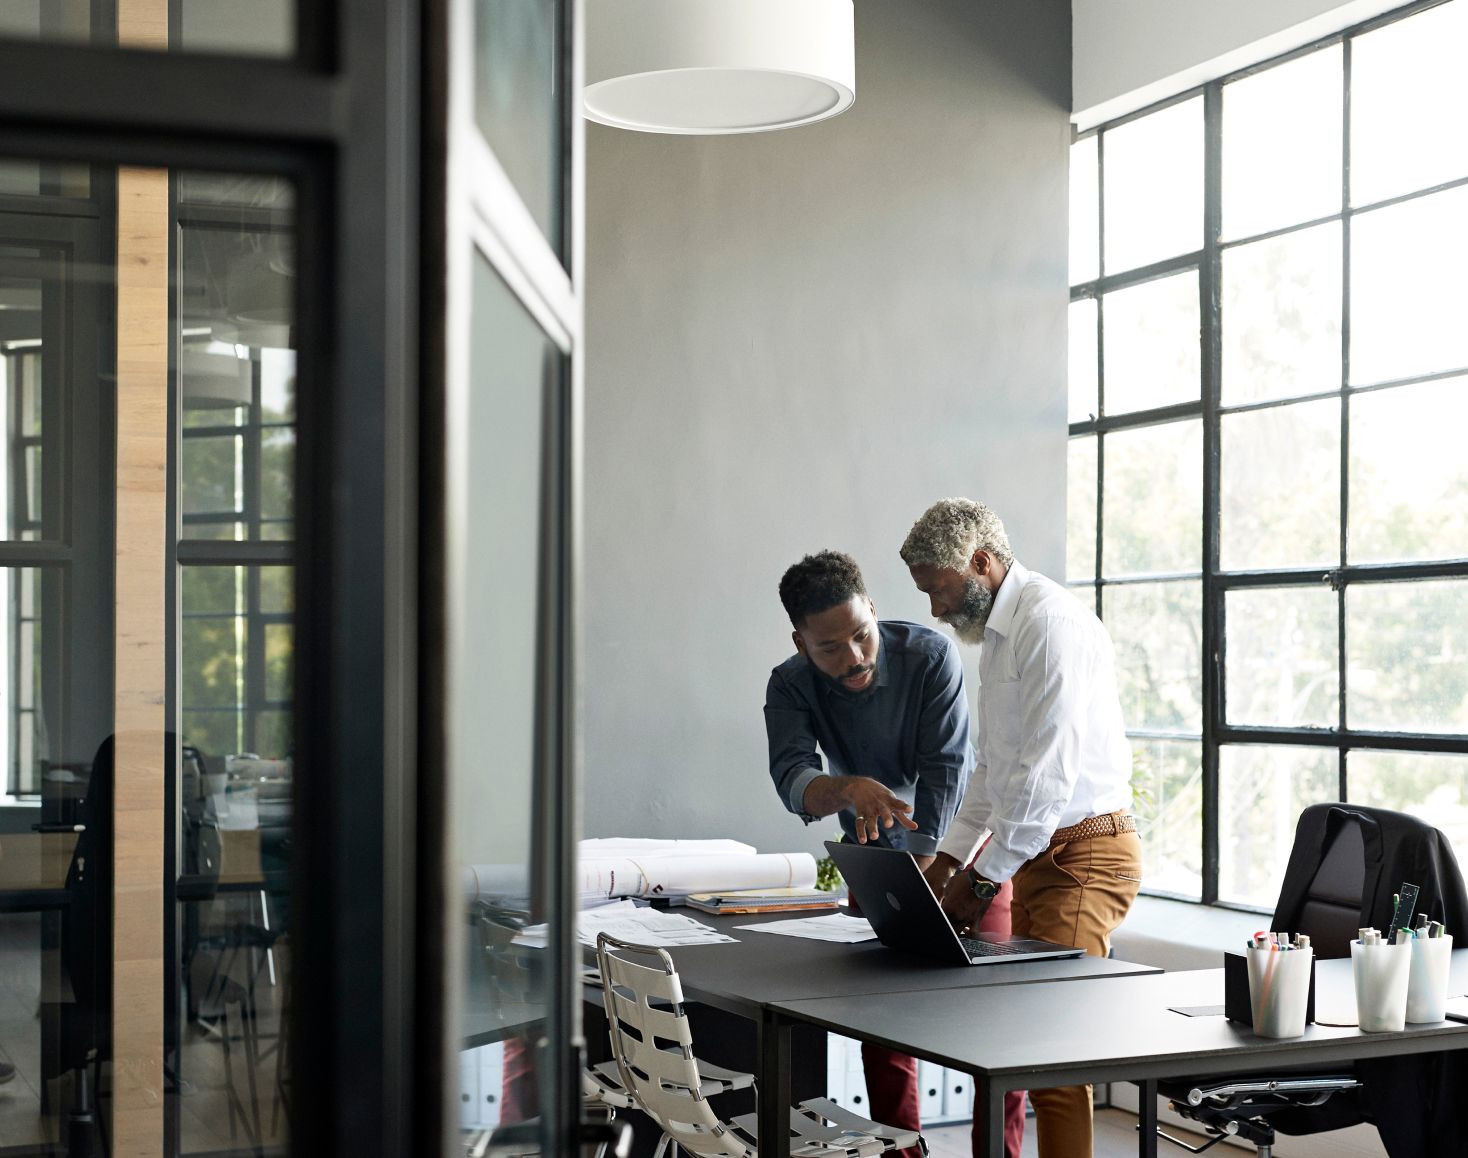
xmin=1066 ymin=0 xmax=1468 ymax=908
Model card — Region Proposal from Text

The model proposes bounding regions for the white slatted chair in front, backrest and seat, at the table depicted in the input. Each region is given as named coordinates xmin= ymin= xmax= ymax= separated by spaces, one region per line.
xmin=596 ymin=933 xmax=928 ymax=1158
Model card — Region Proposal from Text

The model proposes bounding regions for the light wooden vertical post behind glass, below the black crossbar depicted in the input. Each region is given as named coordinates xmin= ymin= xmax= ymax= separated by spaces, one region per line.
xmin=112 ymin=165 xmax=169 ymax=1158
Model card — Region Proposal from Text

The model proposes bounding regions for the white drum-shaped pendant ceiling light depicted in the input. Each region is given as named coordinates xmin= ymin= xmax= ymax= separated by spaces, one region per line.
xmin=584 ymin=0 xmax=856 ymax=135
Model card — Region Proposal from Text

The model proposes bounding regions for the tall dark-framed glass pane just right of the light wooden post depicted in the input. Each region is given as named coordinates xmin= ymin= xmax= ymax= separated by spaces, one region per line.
xmin=170 ymin=173 xmax=297 ymax=1154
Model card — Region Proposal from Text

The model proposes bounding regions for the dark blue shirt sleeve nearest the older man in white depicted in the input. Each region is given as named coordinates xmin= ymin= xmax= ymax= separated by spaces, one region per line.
xmin=907 ymin=646 xmax=973 ymax=857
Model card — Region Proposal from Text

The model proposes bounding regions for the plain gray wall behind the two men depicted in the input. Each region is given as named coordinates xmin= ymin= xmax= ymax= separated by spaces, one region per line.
xmin=583 ymin=0 xmax=1070 ymax=851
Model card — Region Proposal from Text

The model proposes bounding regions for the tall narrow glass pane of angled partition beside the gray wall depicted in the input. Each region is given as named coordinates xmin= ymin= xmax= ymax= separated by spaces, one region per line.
xmin=449 ymin=250 xmax=558 ymax=1129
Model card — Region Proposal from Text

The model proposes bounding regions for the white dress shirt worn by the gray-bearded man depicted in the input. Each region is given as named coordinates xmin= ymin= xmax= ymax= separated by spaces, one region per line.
xmin=938 ymin=561 xmax=1132 ymax=881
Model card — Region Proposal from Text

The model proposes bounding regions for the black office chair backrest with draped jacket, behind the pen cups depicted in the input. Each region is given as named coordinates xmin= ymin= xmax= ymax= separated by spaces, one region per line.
xmin=1273 ymin=803 xmax=1468 ymax=958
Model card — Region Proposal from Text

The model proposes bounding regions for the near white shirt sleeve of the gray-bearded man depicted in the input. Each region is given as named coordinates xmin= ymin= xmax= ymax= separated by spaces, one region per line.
xmin=975 ymin=616 xmax=1094 ymax=881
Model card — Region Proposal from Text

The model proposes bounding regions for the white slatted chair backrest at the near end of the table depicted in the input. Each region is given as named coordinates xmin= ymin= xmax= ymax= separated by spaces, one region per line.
xmin=596 ymin=933 xmax=756 ymax=1158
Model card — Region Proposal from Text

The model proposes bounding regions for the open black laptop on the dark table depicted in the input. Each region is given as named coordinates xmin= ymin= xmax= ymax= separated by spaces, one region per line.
xmin=826 ymin=841 xmax=1085 ymax=964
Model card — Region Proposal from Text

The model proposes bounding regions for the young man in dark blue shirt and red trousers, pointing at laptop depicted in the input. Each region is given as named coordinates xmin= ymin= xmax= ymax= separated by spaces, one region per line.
xmin=765 ymin=550 xmax=1025 ymax=1158
